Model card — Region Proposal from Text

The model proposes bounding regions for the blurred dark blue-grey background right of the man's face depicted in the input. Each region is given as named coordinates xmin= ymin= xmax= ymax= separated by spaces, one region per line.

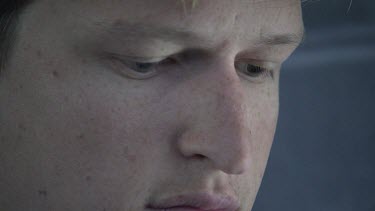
xmin=253 ymin=0 xmax=375 ymax=211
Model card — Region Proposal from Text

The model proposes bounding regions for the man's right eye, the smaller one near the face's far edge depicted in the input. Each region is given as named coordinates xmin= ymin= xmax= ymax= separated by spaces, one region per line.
xmin=235 ymin=61 xmax=273 ymax=82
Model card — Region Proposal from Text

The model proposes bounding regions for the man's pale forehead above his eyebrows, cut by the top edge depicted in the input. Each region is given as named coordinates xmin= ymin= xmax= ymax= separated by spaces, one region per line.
xmin=36 ymin=0 xmax=303 ymax=45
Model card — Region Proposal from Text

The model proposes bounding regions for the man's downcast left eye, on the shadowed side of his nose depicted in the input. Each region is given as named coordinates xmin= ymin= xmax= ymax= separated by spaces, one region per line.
xmin=113 ymin=58 xmax=176 ymax=80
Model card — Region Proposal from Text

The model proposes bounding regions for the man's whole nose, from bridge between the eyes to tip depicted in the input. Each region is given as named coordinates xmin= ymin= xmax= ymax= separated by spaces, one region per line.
xmin=177 ymin=57 xmax=251 ymax=174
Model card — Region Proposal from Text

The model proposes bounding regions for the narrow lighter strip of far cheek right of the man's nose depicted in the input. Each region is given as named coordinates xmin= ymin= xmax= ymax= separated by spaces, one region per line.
xmin=237 ymin=81 xmax=278 ymax=209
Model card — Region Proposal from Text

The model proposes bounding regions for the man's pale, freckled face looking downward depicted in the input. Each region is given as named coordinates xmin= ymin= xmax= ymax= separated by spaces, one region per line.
xmin=0 ymin=0 xmax=302 ymax=211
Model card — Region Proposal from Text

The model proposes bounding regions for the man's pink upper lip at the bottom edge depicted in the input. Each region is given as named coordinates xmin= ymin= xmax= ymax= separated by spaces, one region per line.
xmin=147 ymin=192 xmax=240 ymax=211
